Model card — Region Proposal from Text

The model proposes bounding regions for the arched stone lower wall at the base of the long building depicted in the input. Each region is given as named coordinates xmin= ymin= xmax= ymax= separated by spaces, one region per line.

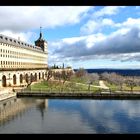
xmin=0 ymin=70 xmax=46 ymax=87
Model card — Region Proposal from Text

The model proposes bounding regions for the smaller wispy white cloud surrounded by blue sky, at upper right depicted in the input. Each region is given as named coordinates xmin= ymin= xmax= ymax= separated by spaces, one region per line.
xmin=80 ymin=6 xmax=125 ymax=34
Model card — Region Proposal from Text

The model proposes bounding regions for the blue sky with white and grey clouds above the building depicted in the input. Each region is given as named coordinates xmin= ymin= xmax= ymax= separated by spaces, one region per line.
xmin=0 ymin=6 xmax=140 ymax=69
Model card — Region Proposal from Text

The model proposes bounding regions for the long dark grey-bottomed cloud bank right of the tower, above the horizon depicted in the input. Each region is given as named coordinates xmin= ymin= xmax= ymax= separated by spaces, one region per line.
xmin=50 ymin=28 xmax=140 ymax=64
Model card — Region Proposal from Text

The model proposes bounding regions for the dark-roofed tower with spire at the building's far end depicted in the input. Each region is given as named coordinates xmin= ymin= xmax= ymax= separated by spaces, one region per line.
xmin=35 ymin=27 xmax=48 ymax=52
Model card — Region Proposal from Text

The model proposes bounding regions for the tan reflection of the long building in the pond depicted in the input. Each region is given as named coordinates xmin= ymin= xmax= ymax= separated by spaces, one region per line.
xmin=0 ymin=97 xmax=48 ymax=123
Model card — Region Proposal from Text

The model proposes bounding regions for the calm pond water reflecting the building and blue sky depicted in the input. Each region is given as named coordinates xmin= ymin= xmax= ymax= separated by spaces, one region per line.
xmin=0 ymin=98 xmax=140 ymax=134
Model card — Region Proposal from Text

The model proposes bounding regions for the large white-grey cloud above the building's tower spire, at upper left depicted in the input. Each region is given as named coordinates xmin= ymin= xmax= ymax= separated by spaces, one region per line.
xmin=0 ymin=6 xmax=92 ymax=32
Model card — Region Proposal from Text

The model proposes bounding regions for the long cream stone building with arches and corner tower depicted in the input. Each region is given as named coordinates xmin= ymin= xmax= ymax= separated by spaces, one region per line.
xmin=0 ymin=27 xmax=48 ymax=87
